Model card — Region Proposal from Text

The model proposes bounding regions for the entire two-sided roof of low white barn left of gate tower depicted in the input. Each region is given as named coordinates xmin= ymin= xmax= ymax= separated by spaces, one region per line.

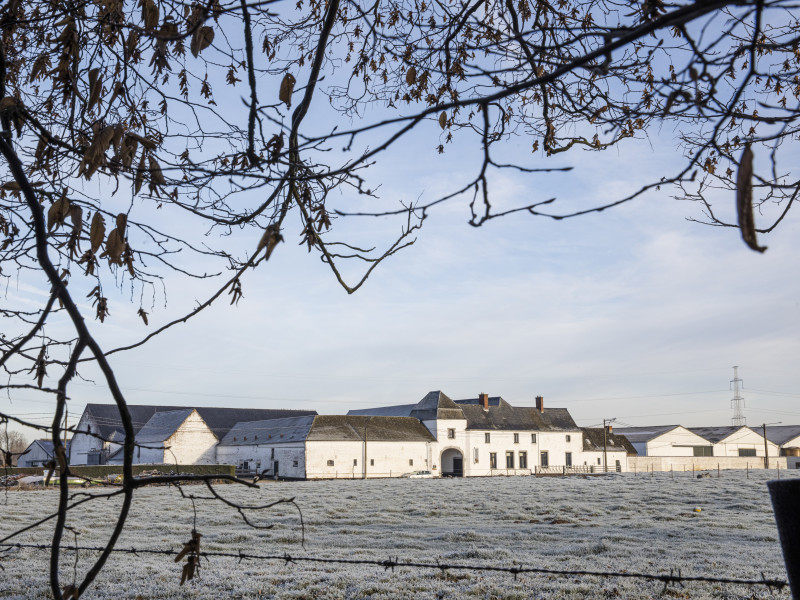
xmin=220 ymin=415 xmax=434 ymax=446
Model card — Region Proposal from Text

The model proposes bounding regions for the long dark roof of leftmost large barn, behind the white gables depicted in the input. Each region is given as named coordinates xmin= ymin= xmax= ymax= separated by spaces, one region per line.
xmin=86 ymin=404 xmax=317 ymax=439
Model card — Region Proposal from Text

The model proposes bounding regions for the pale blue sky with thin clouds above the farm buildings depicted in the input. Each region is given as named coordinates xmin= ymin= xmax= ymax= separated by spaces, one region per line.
xmin=0 ymin=14 xmax=800 ymax=438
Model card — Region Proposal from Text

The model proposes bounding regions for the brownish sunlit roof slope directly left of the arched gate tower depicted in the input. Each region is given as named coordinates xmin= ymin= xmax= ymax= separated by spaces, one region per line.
xmin=307 ymin=415 xmax=435 ymax=443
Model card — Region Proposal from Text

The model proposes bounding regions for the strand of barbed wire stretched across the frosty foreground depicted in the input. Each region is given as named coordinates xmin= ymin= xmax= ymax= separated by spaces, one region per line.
xmin=0 ymin=543 xmax=788 ymax=592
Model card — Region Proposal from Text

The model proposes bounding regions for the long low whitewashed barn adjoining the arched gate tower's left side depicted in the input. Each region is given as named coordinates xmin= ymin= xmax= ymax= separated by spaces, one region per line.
xmin=217 ymin=415 xmax=435 ymax=479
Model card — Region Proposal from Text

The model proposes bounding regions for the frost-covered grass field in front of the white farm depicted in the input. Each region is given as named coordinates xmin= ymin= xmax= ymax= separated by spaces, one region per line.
xmin=0 ymin=471 xmax=800 ymax=600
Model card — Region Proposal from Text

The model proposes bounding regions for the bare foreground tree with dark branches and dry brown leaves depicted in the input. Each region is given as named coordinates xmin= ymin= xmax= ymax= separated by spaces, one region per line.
xmin=0 ymin=0 xmax=800 ymax=599
